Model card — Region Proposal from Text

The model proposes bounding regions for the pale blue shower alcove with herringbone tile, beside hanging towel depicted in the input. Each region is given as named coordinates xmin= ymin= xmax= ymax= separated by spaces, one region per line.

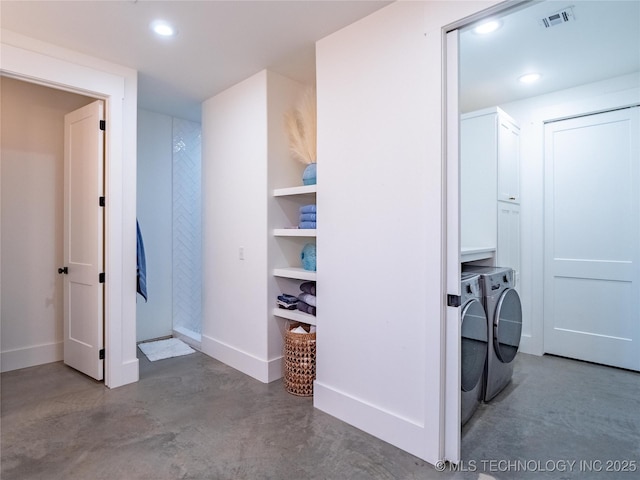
xmin=136 ymin=109 xmax=202 ymax=350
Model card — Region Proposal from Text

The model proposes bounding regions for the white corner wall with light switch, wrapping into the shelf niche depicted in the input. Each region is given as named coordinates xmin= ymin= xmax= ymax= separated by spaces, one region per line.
xmin=202 ymin=70 xmax=304 ymax=382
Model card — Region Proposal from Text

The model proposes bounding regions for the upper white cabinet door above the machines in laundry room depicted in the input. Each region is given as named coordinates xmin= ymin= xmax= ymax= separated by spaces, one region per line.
xmin=498 ymin=116 xmax=520 ymax=203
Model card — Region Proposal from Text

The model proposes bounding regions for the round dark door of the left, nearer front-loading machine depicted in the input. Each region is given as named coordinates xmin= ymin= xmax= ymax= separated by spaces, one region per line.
xmin=460 ymin=300 xmax=488 ymax=392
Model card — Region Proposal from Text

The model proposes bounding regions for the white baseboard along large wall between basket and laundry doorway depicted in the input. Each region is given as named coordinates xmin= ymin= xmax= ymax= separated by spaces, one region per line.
xmin=313 ymin=380 xmax=438 ymax=464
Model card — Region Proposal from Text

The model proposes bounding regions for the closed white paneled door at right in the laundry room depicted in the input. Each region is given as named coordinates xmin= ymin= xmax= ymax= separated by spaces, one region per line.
xmin=544 ymin=107 xmax=640 ymax=370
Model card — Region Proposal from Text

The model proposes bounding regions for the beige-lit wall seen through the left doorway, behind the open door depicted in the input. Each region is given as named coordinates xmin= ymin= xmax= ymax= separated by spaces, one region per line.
xmin=0 ymin=77 xmax=95 ymax=372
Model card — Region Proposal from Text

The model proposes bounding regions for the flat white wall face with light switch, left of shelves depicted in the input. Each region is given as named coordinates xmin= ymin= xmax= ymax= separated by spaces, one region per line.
xmin=202 ymin=71 xmax=268 ymax=381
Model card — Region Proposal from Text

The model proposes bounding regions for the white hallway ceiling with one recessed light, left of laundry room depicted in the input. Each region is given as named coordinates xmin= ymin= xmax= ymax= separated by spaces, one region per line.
xmin=0 ymin=0 xmax=391 ymax=121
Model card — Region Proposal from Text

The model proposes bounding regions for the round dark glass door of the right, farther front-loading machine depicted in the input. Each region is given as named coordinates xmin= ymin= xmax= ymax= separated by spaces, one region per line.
xmin=493 ymin=288 xmax=522 ymax=363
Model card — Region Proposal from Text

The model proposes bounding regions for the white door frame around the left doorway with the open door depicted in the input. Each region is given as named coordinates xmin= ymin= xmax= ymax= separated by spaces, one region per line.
xmin=0 ymin=35 xmax=139 ymax=388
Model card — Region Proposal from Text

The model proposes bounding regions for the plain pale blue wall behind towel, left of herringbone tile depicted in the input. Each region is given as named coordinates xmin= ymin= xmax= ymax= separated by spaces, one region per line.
xmin=136 ymin=109 xmax=173 ymax=341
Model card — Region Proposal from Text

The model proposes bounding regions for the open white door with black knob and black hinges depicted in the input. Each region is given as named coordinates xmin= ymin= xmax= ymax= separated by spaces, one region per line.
xmin=61 ymin=101 xmax=104 ymax=380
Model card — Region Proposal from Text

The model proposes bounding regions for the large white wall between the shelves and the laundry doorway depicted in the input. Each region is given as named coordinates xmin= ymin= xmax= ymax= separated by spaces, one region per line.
xmin=314 ymin=2 xmax=495 ymax=463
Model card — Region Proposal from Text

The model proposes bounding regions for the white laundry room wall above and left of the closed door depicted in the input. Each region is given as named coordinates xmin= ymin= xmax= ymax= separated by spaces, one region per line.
xmin=500 ymin=73 xmax=640 ymax=355
